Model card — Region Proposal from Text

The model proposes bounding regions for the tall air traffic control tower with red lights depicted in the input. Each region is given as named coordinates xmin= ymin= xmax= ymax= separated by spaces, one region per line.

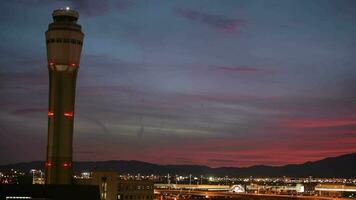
xmin=45 ymin=7 xmax=84 ymax=184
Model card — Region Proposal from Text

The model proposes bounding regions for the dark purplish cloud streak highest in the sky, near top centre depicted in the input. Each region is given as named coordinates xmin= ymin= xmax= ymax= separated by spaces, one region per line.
xmin=174 ymin=8 xmax=244 ymax=32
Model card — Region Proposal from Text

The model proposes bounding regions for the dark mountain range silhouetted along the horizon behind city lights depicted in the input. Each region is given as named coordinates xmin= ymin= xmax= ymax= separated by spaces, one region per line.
xmin=0 ymin=153 xmax=356 ymax=178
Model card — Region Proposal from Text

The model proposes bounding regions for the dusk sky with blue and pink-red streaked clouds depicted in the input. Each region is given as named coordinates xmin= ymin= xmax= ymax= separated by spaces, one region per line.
xmin=0 ymin=0 xmax=356 ymax=167
